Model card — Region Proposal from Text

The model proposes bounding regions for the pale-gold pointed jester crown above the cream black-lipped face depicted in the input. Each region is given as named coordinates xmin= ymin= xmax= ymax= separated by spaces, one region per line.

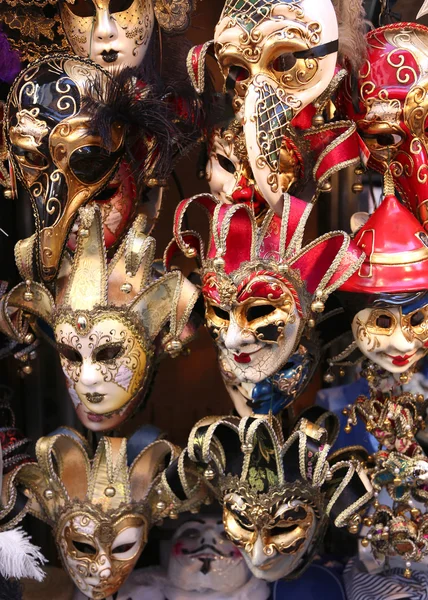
xmin=0 ymin=203 xmax=198 ymax=353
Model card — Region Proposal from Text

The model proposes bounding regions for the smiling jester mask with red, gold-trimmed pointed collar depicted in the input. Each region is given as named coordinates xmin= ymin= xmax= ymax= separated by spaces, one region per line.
xmin=167 ymin=194 xmax=362 ymax=416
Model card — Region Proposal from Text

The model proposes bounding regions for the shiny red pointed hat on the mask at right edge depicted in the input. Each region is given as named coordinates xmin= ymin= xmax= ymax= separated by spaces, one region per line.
xmin=339 ymin=194 xmax=428 ymax=294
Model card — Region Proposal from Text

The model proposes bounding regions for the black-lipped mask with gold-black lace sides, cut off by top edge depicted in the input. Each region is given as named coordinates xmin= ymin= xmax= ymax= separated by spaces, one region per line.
xmin=0 ymin=0 xmax=196 ymax=63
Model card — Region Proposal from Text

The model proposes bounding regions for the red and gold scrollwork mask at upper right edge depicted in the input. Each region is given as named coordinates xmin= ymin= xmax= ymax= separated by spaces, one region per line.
xmin=342 ymin=23 xmax=428 ymax=228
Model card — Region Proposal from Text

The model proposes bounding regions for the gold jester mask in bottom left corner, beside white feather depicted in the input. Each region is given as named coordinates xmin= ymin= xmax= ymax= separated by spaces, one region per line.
xmin=2 ymin=426 xmax=196 ymax=600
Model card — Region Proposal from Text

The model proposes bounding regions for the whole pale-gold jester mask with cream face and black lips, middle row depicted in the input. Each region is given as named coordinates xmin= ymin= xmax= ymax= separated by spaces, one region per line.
xmin=1 ymin=204 xmax=198 ymax=431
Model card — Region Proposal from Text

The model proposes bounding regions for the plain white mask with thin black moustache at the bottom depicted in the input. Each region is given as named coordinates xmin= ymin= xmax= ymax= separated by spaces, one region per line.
xmin=168 ymin=515 xmax=250 ymax=594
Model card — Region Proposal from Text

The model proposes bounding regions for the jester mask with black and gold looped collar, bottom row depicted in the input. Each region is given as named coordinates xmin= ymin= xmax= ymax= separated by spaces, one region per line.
xmin=187 ymin=416 xmax=372 ymax=581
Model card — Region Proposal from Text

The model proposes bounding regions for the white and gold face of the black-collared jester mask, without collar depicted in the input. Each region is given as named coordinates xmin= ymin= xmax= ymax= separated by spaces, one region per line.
xmin=223 ymin=493 xmax=317 ymax=581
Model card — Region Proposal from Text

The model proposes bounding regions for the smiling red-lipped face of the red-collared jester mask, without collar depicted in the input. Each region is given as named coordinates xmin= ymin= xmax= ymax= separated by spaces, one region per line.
xmin=206 ymin=277 xmax=301 ymax=383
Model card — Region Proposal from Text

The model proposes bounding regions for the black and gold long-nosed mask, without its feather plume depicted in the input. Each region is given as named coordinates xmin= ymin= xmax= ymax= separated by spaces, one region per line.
xmin=5 ymin=55 xmax=124 ymax=281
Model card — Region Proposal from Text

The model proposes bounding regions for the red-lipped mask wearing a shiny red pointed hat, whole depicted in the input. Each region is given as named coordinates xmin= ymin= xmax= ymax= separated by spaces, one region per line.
xmin=340 ymin=185 xmax=428 ymax=374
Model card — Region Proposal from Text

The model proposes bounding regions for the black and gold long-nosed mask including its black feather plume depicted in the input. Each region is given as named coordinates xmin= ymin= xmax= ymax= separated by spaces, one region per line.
xmin=5 ymin=55 xmax=181 ymax=282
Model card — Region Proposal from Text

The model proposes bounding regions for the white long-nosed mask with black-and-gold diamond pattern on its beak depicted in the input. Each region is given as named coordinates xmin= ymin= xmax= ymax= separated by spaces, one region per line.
xmin=214 ymin=0 xmax=338 ymax=207
